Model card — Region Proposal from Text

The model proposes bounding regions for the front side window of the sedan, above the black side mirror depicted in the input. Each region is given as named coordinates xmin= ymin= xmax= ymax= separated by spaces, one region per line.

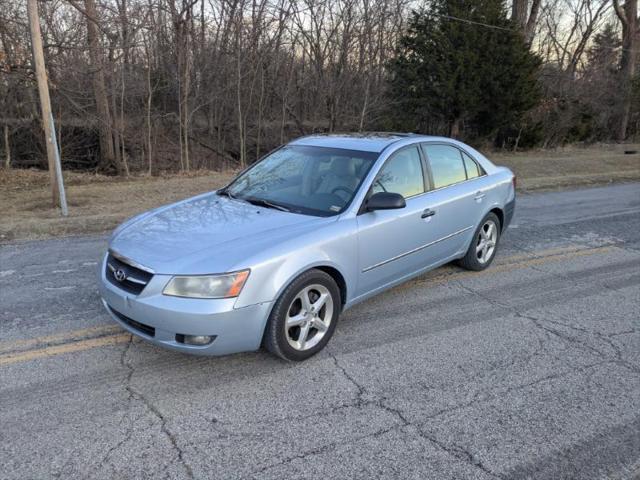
xmin=372 ymin=146 xmax=424 ymax=198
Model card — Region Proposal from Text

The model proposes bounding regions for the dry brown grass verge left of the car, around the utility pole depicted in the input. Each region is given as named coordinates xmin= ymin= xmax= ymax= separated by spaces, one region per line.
xmin=0 ymin=170 xmax=234 ymax=242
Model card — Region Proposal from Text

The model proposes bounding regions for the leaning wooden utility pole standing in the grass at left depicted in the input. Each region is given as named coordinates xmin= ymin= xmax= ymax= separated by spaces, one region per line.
xmin=27 ymin=0 xmax=68 ymax=217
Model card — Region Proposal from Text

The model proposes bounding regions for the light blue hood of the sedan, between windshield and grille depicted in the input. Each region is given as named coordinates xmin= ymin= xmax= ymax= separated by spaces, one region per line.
xmin=109 ymin=192 xmax=333 ymax=275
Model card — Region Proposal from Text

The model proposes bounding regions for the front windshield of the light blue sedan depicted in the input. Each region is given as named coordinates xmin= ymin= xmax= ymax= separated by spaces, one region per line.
xmin=218 ymin=145 xmax=378 ymax=216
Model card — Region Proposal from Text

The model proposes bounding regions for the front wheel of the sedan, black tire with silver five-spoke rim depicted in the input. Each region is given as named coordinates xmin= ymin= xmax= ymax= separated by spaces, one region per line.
xmin=263 ymin=269 xmax=342 ymax=362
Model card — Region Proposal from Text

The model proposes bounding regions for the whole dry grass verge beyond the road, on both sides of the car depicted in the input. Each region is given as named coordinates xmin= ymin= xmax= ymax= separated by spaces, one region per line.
xmin=0 ymin=145 xmax=640 ymax=242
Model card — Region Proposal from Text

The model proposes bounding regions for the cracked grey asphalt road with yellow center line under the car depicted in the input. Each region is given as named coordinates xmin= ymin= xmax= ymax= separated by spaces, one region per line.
xmin=0 ymin=184 xmax=640 ymax=480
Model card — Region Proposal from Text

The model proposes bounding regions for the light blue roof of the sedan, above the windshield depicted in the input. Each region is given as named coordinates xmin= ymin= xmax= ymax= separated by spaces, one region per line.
xmin=289 ymin=132 xmax=438 ymax=153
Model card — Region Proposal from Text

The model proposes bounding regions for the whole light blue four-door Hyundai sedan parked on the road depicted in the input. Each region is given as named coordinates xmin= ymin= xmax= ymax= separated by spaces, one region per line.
xmin=99 ymin=134 xmax=515 ymax=361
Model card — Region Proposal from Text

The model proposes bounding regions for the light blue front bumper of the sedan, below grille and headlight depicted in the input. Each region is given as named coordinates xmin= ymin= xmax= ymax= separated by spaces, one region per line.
xmin=99 ymin=257 xmax=272 ymax=355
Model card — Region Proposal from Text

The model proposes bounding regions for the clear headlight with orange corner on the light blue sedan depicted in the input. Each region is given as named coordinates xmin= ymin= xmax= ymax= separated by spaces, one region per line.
xmin=162 ymin=270 xmax=249 ymax=298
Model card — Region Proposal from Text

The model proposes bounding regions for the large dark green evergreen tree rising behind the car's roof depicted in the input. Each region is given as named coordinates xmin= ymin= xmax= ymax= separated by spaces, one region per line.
xmin=390 ymin=0 xmax=540 ymax=139
